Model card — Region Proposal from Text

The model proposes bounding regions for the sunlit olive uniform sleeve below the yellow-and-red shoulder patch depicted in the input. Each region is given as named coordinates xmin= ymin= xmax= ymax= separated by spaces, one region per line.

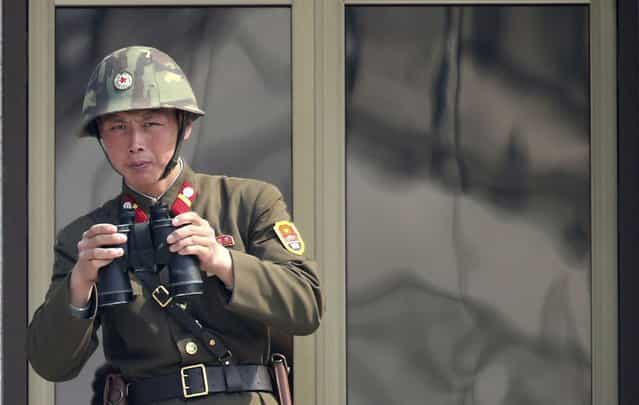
xmin=227 ymin=185 xmax=323 ymax=335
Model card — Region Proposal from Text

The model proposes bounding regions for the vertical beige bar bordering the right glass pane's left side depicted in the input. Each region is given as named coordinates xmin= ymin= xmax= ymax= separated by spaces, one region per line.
xmin=314 ymin=0 xmax=347 ymax=405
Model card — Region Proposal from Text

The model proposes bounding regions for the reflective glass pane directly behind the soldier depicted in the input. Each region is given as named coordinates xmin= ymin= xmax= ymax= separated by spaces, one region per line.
xmin=55 ymin=7 xmax=292 ymax=405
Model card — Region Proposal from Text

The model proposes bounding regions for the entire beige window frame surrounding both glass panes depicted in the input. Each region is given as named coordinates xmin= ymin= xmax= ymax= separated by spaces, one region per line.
xmin=27 ymin=0 xmax=616 ymax=405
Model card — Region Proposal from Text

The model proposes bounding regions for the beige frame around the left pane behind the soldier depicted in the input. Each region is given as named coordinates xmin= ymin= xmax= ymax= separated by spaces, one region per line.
xmin=27 ymin=0 xmax=321 ymax=405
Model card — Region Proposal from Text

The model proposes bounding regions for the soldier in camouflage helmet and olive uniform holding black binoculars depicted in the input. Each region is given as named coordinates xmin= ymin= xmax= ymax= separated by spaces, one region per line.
xmin=28 ymin=46 xmax=323 ymax=405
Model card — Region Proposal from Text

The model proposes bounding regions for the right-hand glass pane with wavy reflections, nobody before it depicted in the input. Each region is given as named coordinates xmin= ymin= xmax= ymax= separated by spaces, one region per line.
xmin=346 ymin=6 xmax=592 ymax=405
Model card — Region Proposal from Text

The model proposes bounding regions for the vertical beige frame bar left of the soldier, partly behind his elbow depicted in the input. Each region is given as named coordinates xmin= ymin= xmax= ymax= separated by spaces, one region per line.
xmin=28 ymin=0 xmax=55 ymax=405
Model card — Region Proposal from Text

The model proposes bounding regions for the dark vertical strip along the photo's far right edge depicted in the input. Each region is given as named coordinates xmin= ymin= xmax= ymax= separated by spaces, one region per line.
xmin=617 ymin=0 xmax=639 ymax=405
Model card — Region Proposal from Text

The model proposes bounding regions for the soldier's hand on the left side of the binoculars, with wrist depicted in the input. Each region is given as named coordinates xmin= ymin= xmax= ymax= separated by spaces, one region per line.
xmin=70 ymin=224 xmax=126 ymax=307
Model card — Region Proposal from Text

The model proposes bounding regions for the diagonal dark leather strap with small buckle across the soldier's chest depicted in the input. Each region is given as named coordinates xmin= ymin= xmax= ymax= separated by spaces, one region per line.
xmin=135 ymin=270 xmax=231 ymax=365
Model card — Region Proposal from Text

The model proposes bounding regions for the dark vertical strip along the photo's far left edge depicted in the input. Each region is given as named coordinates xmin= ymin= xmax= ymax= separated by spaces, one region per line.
xmin=0 ymin=0 xmax=29 ymax=404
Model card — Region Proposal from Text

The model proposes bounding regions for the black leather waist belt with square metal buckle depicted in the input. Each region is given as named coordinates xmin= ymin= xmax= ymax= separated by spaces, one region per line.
xmin=128 ymin=364 xmax=273 ymax=405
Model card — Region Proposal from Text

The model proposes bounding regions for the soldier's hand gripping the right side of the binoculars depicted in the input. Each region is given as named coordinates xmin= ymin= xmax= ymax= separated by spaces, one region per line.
xmin=166 ymin=211 xmax=234 ymax=287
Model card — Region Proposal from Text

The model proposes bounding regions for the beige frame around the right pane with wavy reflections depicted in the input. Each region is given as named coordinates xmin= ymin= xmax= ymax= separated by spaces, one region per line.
xmin=315 ymin=0 xmax=618 ymax=405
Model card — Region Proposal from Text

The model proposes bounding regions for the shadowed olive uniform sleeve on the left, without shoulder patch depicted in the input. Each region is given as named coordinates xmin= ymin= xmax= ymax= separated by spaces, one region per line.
xmin=27 ymin=232 xmax=100 ymax=381
